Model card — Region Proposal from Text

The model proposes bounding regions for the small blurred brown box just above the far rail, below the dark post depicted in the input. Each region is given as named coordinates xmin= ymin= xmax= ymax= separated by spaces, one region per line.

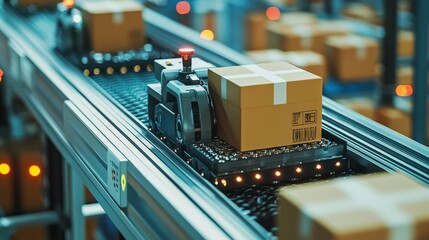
xmin=376 ymin=107 xmax=411 ymax=137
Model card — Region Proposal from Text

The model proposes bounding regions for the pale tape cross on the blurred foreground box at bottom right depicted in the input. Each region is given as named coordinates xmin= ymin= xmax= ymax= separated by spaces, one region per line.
xmin=299 ymin=179 xmax=429 ymax=240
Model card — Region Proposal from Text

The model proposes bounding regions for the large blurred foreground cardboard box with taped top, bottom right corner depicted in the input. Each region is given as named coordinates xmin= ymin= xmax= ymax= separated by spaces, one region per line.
xmin=278 ymin=173 xmax=429 ymax=240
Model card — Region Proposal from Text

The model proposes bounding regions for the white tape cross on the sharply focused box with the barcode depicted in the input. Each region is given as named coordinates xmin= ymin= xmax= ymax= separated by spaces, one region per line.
xmin=220 ymin=64 xmax=304 ymax=105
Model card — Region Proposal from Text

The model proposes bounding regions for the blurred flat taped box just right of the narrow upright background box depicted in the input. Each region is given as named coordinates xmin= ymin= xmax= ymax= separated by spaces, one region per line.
xmin=267 ymin=22 xmax=325 ymax=54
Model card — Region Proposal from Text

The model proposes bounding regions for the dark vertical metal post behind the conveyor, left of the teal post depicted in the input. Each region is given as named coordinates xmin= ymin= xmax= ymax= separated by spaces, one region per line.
xmin=381 ymin=0 xmax=398 ymax=106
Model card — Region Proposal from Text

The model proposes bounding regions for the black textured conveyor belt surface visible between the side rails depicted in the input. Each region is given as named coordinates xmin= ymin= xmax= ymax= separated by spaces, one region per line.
xmin=92 ymin=72 xmax=355 ymax=236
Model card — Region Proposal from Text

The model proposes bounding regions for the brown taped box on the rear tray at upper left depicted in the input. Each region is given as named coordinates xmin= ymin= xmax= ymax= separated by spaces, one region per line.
xmin=79 ymin=1 xmax=144 ymax=53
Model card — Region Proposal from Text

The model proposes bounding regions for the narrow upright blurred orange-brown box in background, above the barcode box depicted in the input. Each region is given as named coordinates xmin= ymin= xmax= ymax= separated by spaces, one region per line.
xmin=245 ymin=13 xmax=267 ymax=50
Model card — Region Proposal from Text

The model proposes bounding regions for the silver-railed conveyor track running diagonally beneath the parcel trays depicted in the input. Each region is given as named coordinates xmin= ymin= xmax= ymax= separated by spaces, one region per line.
xmin=0 ymin=2 xmax=429 ymax=239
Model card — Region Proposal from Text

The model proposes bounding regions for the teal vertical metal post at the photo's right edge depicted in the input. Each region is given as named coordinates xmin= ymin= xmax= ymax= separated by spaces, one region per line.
xmin=412 ymin=0 xmax=429 ymax=145
